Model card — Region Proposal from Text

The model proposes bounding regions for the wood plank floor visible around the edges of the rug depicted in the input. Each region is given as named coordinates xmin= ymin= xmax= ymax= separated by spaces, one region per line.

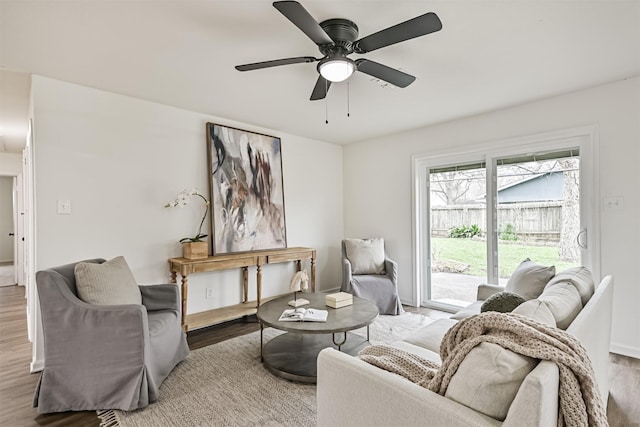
xmin=0 ymin=286 xmax=640 ymax=427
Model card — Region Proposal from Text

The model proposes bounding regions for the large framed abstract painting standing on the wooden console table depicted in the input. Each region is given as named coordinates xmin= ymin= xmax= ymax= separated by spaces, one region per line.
xmin=207 ymin=123 xmax=287 ymax=255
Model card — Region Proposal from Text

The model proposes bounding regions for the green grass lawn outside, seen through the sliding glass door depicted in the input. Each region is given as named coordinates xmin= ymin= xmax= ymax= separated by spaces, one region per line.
xmin=431 ymin=237 xmax=579 ymax=277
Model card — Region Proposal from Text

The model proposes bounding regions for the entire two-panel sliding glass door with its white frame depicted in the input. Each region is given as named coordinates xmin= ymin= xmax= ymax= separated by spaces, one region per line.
xmin=415 ymin=130 xmax=596 ymax=310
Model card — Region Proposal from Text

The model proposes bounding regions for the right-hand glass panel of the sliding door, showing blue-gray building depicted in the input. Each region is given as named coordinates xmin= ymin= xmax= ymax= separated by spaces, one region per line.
xmin=496 ymin=153 xmax=581 ymax=281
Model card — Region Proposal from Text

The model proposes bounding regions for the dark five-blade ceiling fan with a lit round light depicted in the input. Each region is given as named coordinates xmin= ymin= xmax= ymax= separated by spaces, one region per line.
xmin=236 ymin=1 xmax=442 ymax=101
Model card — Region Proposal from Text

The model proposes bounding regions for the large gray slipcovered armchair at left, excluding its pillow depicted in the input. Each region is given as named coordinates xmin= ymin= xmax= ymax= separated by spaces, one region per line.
xmin=33 ymin=259 xmax=189 ymax=413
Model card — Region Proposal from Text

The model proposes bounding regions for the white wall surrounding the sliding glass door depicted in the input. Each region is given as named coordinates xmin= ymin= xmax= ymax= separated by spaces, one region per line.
xmin=344 ymin=77 xmax=640 ymax=357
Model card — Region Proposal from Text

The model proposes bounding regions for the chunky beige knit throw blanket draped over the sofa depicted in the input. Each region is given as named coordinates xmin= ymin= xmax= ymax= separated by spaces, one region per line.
xmin=359 ymin=311 xmax=608 ymax=427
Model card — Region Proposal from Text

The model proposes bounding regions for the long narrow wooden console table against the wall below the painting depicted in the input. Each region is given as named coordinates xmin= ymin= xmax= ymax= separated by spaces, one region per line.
xmin=169 ymin=248 xmax=316 ymax=332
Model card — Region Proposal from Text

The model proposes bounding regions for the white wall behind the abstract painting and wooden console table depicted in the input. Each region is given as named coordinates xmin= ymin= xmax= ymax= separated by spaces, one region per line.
xmin=32 ymin=76 xmax=343 ymax=313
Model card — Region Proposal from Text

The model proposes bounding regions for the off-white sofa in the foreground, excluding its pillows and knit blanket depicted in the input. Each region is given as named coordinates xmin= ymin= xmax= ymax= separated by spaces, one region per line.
xmin=317 ymin=270 xmax=613 ymax=427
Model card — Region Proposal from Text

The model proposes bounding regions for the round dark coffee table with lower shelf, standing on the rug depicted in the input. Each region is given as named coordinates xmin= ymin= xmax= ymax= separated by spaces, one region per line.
xmin=257 ymin=293 xmax=378 ymax=383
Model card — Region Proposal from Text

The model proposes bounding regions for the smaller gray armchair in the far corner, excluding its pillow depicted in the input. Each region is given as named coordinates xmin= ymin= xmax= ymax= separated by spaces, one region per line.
xmin=340 ymin=240 xmax=404 ymax=315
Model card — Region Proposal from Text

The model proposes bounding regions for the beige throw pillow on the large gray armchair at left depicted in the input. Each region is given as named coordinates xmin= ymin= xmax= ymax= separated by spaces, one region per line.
xmin=74 ymin=256 xmax=142 ymax=305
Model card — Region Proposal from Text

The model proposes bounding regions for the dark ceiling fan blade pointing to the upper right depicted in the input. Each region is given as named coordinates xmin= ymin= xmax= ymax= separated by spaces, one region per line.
xmin=354 ymin=12 xmax=442 ymax=53
